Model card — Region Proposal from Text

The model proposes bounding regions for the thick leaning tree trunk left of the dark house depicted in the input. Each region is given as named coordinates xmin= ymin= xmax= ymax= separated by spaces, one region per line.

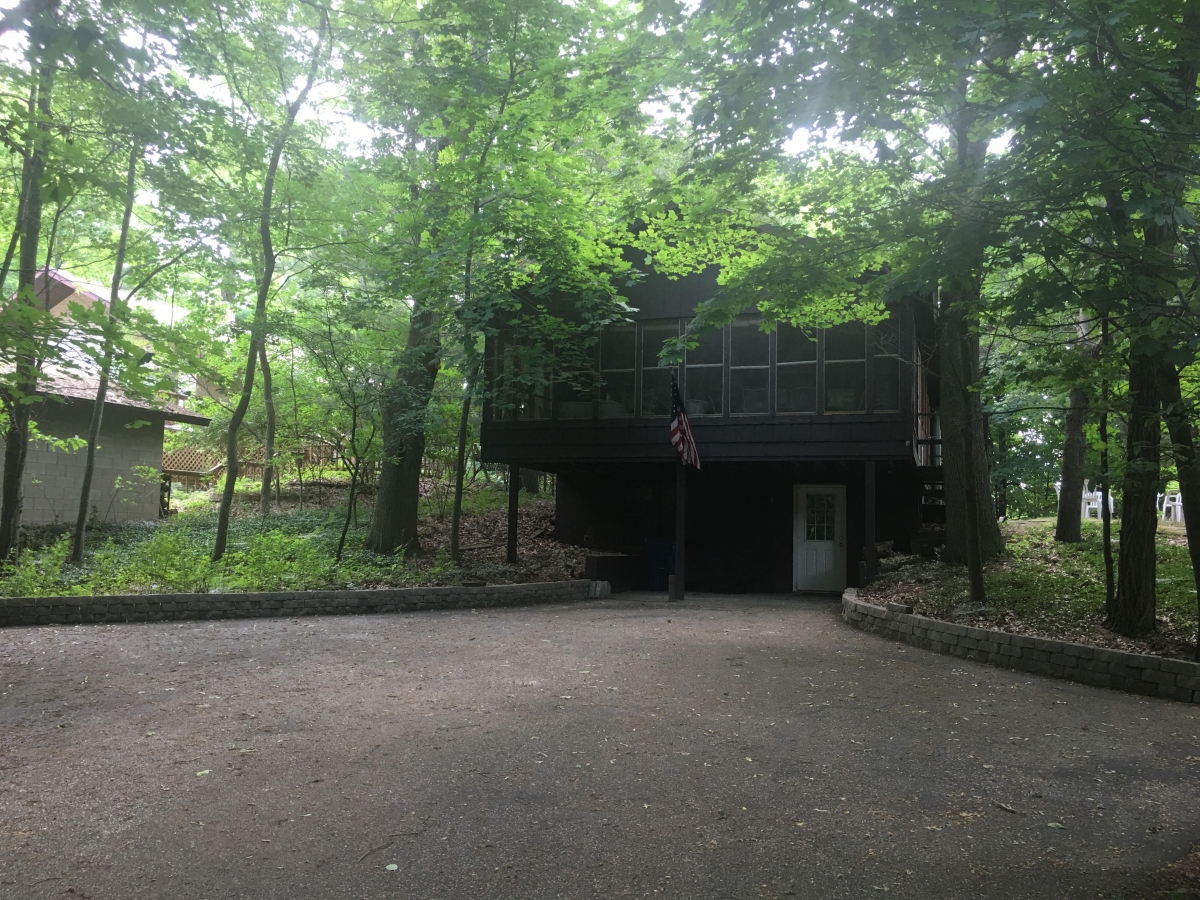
xmin=366 ymin=306 xmax=442 ymax=553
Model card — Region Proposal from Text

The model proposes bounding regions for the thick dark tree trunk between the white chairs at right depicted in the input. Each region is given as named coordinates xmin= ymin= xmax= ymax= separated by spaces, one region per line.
xmin=1105 ymin=353 xmax=1162 ymax=637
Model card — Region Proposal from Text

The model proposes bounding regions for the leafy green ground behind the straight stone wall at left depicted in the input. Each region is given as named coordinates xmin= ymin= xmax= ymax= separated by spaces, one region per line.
xmin=0 ymin=482 xmax=584 ymax=598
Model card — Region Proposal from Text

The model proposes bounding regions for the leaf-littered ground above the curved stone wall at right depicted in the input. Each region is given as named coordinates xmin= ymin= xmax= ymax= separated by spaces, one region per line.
xmin=859 ymin=518 xmax=1196 ymax=660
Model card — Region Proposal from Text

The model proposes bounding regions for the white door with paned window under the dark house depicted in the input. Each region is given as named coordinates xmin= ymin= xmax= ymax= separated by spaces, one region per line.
xmin=792 ymin=485 xmax=846 ymax=592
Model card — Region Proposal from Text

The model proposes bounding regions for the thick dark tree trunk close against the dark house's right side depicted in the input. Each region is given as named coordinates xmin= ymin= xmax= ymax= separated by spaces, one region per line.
xmin=937 ymin=314 xmax=1004 ymax=564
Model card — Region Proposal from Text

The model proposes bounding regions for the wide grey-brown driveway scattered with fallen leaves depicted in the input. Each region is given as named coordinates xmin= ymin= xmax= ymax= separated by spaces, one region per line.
xmin=0 ymin=595 xmax=1200 ymax=900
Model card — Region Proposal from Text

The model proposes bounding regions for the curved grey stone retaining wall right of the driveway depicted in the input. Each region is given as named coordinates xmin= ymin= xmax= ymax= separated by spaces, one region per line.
xmin=841 ymin=588 xmax=1200 ymax=703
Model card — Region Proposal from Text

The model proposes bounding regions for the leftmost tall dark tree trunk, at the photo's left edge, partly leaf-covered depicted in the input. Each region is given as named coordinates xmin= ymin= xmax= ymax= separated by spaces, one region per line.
xmin=0 ymin=54 xmax=54 ymax=562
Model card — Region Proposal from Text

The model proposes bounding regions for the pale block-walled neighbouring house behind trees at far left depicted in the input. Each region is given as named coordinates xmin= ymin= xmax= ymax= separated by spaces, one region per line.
xmin=0 ymin=270 xmax=209 ymax=526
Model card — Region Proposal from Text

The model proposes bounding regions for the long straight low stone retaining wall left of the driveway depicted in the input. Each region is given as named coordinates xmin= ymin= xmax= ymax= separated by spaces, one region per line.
xmin=0 ymin=580 xmax=611 ymax=626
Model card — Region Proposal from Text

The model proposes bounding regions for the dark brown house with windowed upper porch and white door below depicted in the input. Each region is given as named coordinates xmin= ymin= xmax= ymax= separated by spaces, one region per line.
xmin=480 ymin=264 xmax=944 ymax=592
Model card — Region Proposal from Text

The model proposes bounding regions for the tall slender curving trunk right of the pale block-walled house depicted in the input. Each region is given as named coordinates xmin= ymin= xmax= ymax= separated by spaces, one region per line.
xmin=212 ymin=19 xmax=332 ymax=562
